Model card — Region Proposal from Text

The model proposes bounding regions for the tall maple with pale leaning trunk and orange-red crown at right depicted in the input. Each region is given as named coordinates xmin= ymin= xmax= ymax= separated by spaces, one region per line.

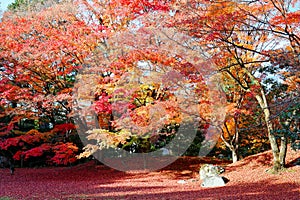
xmin=169 ymin=0 xmax=299 ymax=171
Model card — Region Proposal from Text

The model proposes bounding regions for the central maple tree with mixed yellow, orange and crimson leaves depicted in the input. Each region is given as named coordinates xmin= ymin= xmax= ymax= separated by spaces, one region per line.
xmin=75 ymin=1 xmax=223 ymax=160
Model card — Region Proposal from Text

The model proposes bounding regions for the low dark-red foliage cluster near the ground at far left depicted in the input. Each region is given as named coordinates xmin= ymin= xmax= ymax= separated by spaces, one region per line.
xmin=0 ymin=124 xmax=78 ymax=165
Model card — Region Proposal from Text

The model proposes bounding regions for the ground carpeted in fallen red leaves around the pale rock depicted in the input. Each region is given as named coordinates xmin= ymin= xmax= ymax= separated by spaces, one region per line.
xmin=0 ymin=146 xmax=300 ymax=200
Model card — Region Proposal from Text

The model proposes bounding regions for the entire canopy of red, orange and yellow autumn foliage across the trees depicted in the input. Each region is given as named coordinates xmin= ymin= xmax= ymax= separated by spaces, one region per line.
xmin=0 ymin=0 xmax=300 ymax=170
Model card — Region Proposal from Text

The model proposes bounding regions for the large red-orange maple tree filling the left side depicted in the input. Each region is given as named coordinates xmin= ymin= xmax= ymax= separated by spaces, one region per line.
xmin=0 ymin=0 xmax=95 ymax=164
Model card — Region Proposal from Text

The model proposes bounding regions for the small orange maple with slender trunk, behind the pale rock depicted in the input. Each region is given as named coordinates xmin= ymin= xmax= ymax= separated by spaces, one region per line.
xmin=214 ymin=74 xmax=269 ymax=162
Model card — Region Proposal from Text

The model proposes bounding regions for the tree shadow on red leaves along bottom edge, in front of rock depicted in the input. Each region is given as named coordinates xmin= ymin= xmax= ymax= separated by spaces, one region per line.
xmin=67 ymin=180 xmax=299 ymax=200
